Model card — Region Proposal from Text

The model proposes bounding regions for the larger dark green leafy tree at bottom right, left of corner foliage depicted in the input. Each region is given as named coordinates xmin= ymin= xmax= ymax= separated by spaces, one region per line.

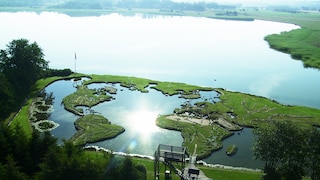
xmin=254 ymin=121 xmax=306 ymax=180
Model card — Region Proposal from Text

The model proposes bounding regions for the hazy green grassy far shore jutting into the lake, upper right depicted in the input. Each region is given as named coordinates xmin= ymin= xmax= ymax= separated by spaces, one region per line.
xmin=245 ymin=10 xmax=320 ymax=69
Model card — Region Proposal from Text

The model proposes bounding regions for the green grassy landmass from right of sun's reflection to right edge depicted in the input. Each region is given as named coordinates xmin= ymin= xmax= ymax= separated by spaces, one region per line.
xmin=157 ymin=89 xmax=320 ymax=158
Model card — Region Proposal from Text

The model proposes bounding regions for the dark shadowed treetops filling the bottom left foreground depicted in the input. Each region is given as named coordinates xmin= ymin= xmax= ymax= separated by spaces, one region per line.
xmin=0 ymin=124 xmax=146 ymax=180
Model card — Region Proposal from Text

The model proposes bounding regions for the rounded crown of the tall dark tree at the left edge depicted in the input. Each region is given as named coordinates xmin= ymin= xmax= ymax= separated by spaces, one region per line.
xmin=0 ymin=39 xmax=48 ymax=99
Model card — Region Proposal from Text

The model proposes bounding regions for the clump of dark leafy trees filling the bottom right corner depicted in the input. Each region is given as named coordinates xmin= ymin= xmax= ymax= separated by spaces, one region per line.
xmin=254 ymin=121 xmax=320 ymax=180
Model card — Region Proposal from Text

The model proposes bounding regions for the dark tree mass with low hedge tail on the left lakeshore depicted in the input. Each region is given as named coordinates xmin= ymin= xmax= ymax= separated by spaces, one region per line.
xmin=0 ymin=39 xmax=72 ymax=121
